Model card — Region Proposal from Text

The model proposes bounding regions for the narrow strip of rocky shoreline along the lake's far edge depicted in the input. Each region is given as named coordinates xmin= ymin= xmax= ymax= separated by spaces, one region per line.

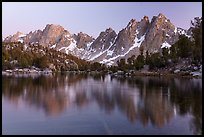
xmin=2 ymin=68 xmax=202 ymax=79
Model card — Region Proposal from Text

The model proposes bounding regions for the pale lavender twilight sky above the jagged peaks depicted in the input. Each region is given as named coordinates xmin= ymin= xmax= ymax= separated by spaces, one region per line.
xmin=2 ymin=2 xmax=202 ymax=38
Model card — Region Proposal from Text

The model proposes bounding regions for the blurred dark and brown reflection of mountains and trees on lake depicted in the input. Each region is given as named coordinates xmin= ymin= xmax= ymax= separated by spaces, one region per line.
xmin=2 ymin=74 xmax=202 ymax=134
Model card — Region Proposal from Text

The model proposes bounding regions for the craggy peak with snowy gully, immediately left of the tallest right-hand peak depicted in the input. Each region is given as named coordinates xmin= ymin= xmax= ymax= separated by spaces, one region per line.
xmin=94 ymin=17 xmax=148 ymax=65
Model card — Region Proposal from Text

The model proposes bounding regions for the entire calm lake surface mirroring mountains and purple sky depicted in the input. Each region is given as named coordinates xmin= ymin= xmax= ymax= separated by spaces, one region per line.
xmin=2 ymin=74 xmax=202 ymax=134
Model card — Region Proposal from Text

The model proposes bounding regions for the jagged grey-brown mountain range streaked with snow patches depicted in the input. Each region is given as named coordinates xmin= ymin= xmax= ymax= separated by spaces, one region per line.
xmin=2 ymin=13 xmax=191 ymax=65
